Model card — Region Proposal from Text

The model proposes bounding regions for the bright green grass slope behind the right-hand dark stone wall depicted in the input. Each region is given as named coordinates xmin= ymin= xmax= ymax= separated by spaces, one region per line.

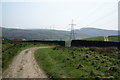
xmin=81 ymin=35 xmax=120 ymax=42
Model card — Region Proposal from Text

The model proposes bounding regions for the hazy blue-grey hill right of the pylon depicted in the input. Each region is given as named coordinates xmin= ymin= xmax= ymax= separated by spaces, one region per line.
xmin=75 ymin=28 xmax=118 ymax=38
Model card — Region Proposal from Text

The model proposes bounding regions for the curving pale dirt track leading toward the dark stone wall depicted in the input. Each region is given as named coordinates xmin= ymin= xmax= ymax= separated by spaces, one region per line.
xmin=3 ymin=46 xmax=52 ymax=78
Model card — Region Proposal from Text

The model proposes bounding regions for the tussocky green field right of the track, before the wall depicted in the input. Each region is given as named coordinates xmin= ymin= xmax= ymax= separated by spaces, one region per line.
xmin=35 ymin=47 xmax=120 ymax=78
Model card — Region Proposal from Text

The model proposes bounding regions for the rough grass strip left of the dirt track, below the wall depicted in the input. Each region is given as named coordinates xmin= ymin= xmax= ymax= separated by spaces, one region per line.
xmin=2 ymin=41 xmax=54 ymax=71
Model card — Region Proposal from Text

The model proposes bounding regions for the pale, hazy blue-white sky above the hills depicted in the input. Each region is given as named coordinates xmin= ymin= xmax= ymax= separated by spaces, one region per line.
xmin=0 ymin=0 xmax=119 ymax=30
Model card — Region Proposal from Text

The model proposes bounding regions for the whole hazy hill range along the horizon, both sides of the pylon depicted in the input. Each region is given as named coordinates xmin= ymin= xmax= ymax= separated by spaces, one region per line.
xmin=2 ymin=28 xmax=118 ymax=40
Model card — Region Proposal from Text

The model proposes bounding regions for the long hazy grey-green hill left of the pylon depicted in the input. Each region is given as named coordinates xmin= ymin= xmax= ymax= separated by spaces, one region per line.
xmin=2 ymin=28 xmax=69 ymax=40
